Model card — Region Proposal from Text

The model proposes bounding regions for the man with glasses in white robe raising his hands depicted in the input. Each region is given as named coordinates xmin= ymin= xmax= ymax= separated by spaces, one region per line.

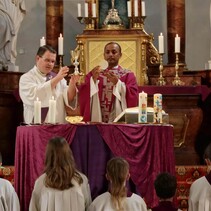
xmin=19 ymin=45 xmax=79 ymax=124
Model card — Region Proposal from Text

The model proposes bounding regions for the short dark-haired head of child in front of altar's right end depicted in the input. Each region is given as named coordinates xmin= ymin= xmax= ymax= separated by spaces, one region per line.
xmin=154 ymin=172 xmax=177 ymax=199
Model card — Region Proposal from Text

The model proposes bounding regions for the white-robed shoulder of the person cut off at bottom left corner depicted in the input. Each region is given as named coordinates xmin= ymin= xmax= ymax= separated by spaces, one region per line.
xmin=0 ymin=178 xmax=20 ymax=211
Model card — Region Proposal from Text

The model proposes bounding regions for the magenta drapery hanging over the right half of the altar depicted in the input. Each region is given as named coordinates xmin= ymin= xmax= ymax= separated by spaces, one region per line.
xmin=97 ymin=124 xmax=175 ymax=207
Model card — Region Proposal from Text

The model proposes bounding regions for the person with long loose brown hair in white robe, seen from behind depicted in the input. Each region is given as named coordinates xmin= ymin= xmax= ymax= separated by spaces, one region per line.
xmin=29 ymin=137 xmax=91 ymax=211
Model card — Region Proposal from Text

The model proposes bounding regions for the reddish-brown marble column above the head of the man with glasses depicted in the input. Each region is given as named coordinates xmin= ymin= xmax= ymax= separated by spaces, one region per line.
xmin=46 ymin=0 xmax=63 ymax=52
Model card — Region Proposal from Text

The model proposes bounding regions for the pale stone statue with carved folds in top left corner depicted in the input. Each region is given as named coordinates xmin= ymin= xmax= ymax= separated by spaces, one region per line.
xmin=0 ymin=0 xmax=26 ymax=69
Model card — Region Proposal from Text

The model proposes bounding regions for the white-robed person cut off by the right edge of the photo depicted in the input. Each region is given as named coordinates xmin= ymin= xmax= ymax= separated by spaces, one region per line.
xmin=188 ymin=143 xmax=211 ymax=211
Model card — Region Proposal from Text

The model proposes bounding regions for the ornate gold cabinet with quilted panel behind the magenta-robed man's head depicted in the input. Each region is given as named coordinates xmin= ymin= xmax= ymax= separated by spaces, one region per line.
xmin=77 ymin=34 xmax=149 ymax=85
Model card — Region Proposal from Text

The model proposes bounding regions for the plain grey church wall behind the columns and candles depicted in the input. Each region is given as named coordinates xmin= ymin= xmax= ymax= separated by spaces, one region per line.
xmin=16 ymin=0 xmax=211 ymax=72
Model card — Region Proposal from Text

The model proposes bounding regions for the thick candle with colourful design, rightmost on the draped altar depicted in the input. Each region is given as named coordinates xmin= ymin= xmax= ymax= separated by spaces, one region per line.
xmin=153 ymin=93 xmax=162 ymax=123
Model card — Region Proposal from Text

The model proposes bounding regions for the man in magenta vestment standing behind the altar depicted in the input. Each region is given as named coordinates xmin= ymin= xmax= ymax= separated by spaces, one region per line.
xmin=79 ymin=42 xmax=138 ymax=122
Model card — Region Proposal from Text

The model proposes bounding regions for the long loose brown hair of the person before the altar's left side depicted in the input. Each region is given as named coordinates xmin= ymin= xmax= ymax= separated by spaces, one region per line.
xmin=44 ymin=137 xmax=83 ymax=190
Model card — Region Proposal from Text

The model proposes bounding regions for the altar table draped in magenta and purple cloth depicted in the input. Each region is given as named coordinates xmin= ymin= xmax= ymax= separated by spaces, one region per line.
xmin=14 ymin=123 xmax=175 ymax=211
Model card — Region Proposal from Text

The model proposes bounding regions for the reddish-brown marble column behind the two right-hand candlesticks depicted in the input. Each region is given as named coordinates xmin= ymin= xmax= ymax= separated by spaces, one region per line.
xmin=167 ymin=0 xmax=186 ymax=64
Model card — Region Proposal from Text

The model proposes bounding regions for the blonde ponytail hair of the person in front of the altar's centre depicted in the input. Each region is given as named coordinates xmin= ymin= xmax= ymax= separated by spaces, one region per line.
xmin=106 ymin=157 xmax=129 ymax=211
